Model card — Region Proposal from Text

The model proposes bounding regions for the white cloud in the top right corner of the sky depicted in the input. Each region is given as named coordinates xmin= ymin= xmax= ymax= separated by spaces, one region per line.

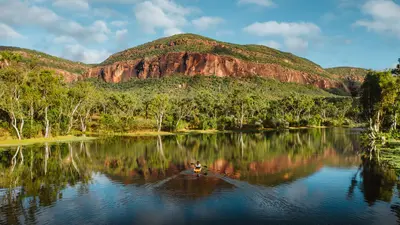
xmin=355 ymin=0 xmax=400 ymax=39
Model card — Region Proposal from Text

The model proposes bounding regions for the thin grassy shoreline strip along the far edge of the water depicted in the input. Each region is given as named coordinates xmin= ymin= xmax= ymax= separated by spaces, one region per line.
xmin=0 ymin=126 xmax=366 ymax=148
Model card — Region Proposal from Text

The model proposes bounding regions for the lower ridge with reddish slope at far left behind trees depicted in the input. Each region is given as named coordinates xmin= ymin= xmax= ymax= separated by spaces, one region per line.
xmin=0 ymin=46 xmax=90 ymax=82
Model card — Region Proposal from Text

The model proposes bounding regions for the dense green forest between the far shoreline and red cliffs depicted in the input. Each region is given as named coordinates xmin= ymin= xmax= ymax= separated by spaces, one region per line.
xmin=0 ymin=51 xmax=359 ymax=139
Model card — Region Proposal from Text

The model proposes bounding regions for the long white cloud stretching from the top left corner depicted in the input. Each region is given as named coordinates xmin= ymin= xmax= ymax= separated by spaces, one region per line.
xmin=0 ymin=0 xmax=110 ymax=43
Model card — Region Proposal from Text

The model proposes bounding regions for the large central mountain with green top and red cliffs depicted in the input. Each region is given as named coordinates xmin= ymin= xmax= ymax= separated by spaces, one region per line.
xmin=85 ymin=34 xmax=348 ymax=91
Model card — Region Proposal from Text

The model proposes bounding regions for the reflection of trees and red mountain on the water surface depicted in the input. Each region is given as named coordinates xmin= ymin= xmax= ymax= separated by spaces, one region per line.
xmin=0 ymin=129 xmax=399 ymax=224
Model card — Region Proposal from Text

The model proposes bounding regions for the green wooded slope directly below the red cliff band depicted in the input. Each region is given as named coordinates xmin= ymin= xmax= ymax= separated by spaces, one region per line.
xmin=92 ymin=76 xmax=335 ymax=100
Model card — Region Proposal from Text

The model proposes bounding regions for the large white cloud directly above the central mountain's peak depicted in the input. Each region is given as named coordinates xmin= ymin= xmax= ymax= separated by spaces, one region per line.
xmin=134 ymin=0 xmax=191 ymax=34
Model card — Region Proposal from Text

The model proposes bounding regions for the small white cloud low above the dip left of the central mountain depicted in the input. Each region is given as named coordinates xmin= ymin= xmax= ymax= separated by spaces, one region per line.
xmin=63 ymin=44 xmax=111 ymax=63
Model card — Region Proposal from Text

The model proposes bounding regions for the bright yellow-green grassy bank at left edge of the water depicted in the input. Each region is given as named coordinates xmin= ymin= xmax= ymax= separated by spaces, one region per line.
xmin=0 ymin=136 xmax=96 ymax=147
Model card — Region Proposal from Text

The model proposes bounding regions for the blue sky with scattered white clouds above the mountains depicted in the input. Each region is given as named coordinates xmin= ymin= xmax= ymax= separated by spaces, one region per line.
xmin=0 ymin=0 xmax=400 ymax=69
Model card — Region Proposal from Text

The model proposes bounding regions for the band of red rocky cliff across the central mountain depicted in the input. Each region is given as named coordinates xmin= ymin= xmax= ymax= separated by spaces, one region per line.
xmin=84 ymin=52 xmax=345 ymax=89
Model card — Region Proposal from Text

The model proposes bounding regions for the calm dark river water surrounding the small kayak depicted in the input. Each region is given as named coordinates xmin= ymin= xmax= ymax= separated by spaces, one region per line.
xmin=0 ymin=129 xmax=400 ymax=224
